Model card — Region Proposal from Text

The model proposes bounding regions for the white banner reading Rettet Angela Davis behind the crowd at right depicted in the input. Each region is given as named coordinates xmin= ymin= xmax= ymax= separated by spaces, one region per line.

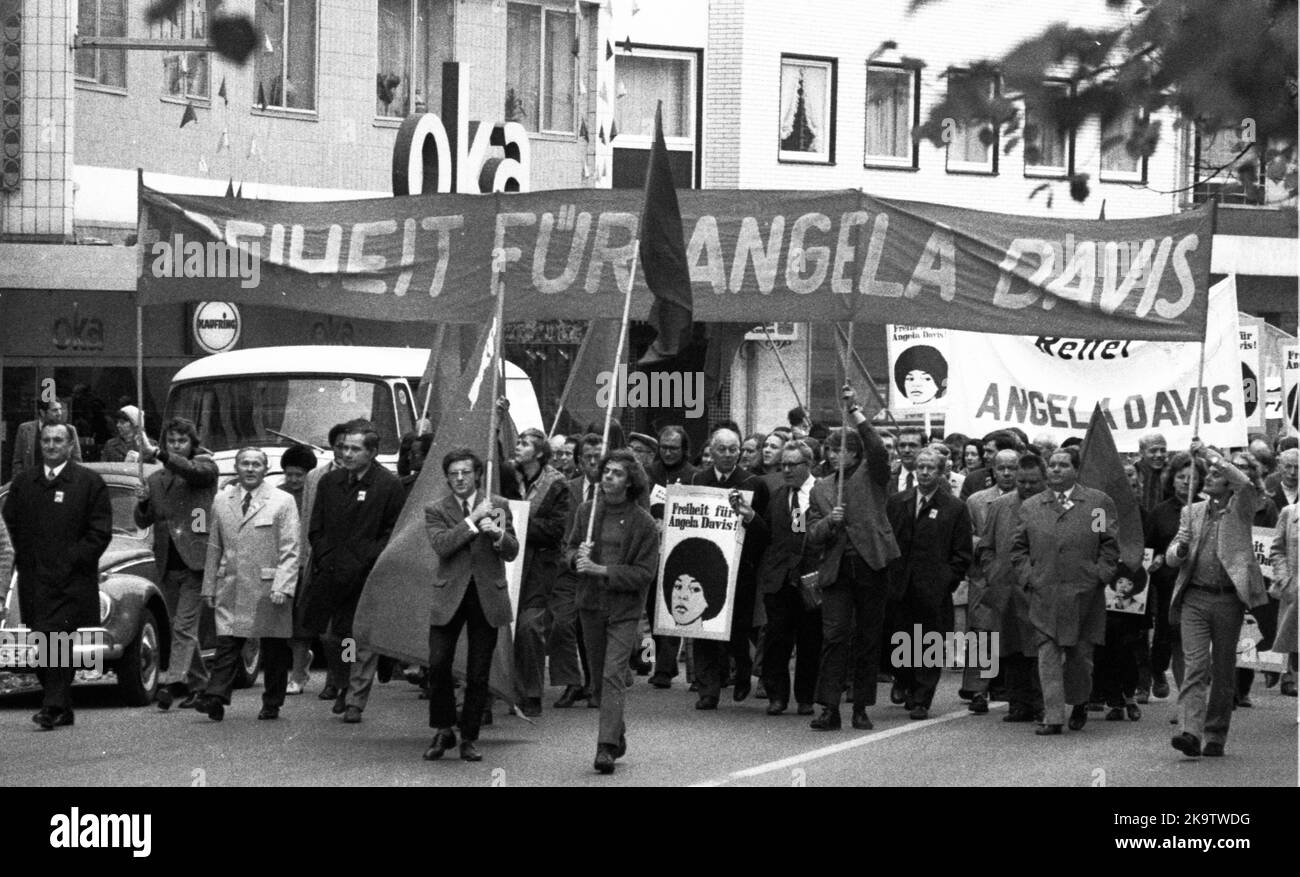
xmin=946 ymin=277 xmax=1245 ymax=452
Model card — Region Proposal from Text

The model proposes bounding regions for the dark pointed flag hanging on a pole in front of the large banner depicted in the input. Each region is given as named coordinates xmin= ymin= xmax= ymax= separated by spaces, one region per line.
xmin=638 ymin=101 xmax=692 ymax=368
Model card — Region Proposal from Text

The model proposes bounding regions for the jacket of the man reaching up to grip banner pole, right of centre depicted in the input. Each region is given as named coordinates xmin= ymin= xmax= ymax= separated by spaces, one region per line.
xmin=807 ymin=421 xmax=898 ymax=586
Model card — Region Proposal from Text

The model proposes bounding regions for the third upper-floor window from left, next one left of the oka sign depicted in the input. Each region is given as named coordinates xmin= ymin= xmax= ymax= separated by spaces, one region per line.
xmin=254 ymin=0 xmax=319 ymax=110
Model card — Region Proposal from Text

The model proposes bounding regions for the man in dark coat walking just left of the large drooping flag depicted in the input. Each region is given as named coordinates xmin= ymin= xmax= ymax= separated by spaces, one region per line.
xmin=303 ymin=427 xmax=406 ymax=724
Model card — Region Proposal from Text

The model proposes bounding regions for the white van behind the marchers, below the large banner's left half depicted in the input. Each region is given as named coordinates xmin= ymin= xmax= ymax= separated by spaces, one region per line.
xmin=164 ymin=346 xmax=543 ymax=481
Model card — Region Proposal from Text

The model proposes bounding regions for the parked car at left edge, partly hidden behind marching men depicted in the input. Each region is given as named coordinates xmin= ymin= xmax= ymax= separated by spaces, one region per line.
xmin=0 ymin=463 xmax=261 ymax=707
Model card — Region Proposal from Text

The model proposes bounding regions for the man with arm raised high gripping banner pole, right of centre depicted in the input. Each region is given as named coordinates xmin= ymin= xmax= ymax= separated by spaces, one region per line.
xmin=805 ymin=383 xmax=899 ymax=731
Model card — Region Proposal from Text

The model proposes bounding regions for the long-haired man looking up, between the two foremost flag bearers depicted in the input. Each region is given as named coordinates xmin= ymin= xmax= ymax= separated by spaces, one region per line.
xmin=501 ymin=429 xmax=569 ymax=717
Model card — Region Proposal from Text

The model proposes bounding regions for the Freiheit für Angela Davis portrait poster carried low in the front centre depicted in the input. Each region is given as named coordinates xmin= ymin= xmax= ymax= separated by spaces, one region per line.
xmin=654 ymin=485 xmax=754 ymax=641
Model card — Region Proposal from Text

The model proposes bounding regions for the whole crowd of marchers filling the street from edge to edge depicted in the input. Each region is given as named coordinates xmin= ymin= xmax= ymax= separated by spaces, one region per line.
xmin=0 ymin=386 xmax=1300 ymax=773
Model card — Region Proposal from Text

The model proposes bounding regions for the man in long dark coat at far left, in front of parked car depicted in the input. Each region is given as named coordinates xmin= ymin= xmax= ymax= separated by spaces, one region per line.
xmin=4 ymin=424 xmax=113 ymax=730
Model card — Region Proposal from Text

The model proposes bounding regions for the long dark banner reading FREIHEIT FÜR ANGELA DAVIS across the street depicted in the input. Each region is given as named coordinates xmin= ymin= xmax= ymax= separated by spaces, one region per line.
xmin=138 ymin=186 xmax=1212 ymax=340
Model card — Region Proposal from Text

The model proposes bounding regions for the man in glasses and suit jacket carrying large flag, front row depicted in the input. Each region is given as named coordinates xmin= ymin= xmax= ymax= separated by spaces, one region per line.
xmin=424 ymin=448 xmax=519 ymax=761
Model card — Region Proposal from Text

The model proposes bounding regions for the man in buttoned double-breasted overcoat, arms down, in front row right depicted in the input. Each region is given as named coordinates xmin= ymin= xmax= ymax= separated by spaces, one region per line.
xmin=1011 ymin=447 xmax=1119 ymax=735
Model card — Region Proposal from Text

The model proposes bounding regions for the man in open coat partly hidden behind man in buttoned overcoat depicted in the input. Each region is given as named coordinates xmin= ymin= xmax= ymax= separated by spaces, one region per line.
xmin=972 ymin=452 xmax=1047 ymax=722
